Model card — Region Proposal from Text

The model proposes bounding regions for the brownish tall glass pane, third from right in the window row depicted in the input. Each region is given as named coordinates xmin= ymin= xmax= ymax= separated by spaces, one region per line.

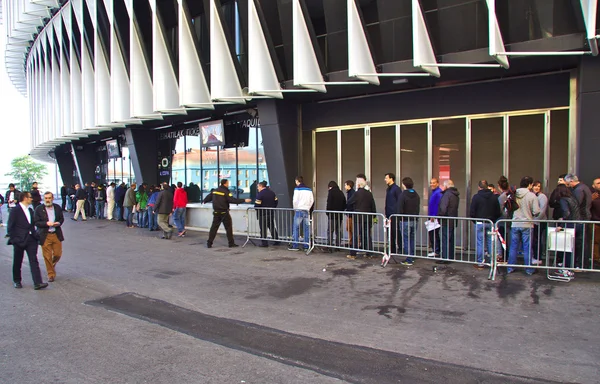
xmin=471 ymin=117 xmax=504 ymax=196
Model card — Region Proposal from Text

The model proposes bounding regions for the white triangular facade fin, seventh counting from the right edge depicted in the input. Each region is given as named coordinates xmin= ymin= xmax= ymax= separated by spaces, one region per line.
xmin=210 ymin=0 xmax=246 ymax=104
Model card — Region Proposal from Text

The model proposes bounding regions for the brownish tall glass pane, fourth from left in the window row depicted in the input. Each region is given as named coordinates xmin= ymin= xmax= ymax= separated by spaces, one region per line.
xmin=397 ymin=124 xmax=429 ymax=215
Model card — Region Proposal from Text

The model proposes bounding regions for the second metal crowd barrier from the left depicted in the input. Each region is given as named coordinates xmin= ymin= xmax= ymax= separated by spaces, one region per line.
xmin=312 ymin=210 xmax=388 ymax=258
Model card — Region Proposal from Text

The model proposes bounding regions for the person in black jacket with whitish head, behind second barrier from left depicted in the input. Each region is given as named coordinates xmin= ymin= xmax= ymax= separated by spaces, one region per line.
xmin=346 ymin=178 xmax=377 ymax=260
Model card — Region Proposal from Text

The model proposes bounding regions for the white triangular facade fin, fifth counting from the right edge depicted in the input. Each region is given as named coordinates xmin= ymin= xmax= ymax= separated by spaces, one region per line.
xmin=292 ymin=0 xmax=327 ymax=92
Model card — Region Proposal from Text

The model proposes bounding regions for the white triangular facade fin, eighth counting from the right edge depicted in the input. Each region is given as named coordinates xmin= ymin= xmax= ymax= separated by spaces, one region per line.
xmin=178 ymin=0 xmax=214 ymax=109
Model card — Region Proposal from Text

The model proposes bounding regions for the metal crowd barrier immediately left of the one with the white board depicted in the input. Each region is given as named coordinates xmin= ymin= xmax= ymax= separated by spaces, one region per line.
xmin=382 ymin=215 xmax=498 ymax=279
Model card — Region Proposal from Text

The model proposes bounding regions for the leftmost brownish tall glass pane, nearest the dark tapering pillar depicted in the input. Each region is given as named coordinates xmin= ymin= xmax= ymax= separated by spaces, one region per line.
xmin=315 ymin=131 xmax=338 ymax=209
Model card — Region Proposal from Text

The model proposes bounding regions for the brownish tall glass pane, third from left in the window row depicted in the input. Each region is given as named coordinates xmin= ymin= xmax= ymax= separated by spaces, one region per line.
xmin=371 ymin=126 xmax=400 ymax=213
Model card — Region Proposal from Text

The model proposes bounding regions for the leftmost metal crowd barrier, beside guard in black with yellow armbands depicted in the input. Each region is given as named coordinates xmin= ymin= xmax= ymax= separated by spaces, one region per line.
xmin=242 ymin=207 xmax=311 ymax=253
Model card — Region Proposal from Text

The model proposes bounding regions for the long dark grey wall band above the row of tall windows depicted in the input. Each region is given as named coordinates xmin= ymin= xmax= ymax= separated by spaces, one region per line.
xmin=302 ymin=72 xmax=569 ymax=130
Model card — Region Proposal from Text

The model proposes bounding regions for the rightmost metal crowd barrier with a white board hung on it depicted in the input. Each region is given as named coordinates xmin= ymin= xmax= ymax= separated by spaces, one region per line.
xmin=494 ymin=220 xmax=600 ymax=282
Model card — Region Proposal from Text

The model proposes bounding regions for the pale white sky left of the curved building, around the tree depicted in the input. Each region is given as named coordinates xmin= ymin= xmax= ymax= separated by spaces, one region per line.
xmin=0 ymin=30 xmax=56 ymax=194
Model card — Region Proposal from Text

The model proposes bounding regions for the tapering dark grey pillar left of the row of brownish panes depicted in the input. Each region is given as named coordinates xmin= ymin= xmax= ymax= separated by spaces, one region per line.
xmin=257 ymin=100 xmax=299 ymax=208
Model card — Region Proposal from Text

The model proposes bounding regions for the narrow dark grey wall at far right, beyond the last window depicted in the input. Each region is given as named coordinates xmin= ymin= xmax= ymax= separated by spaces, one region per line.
xmin=575 ymin=57 xmax=600 ymax=186
